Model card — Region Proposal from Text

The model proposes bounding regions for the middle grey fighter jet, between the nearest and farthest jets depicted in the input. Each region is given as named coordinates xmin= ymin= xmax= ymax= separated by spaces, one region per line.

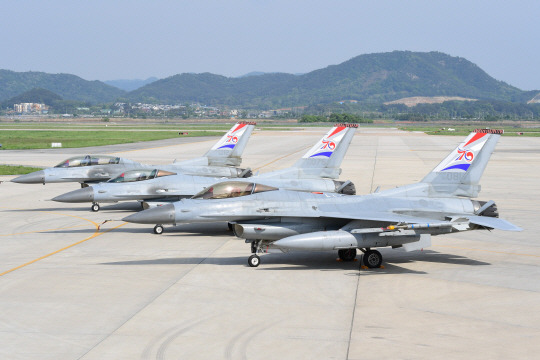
xmin=52 ymin=124 xmax=358 ymax=217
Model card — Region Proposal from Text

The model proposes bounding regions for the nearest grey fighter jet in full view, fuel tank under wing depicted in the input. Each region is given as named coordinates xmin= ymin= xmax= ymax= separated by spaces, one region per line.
xmin=123 ymin=130 xmax=521 ymax=268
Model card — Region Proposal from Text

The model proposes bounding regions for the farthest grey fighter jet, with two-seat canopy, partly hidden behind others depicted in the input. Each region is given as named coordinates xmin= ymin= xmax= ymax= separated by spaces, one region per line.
xmin=11 ymin=122 xmax=255 ymax=187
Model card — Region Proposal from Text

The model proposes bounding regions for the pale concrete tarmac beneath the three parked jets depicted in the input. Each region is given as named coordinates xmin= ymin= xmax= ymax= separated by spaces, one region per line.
xmin=0 ymin=128 xmax=540 ymax=360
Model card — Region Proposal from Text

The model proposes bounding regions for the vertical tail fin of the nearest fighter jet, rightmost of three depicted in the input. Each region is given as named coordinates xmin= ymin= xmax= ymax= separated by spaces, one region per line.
xmin=421 ymin=129 xmax=503 ymax=197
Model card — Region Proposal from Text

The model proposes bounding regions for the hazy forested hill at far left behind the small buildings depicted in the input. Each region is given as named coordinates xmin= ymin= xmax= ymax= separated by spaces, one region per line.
xmin=0 ymin=70 xmax=125 ymax=103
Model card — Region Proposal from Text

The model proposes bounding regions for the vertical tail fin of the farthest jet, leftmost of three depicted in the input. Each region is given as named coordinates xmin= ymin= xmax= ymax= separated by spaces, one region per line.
xmin=204 ymin=121 xmax=257 ymax=166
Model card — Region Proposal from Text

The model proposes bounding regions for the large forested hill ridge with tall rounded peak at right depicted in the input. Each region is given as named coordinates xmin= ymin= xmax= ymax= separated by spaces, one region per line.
xmin=127 ymin=51 xmax=531 ymax=108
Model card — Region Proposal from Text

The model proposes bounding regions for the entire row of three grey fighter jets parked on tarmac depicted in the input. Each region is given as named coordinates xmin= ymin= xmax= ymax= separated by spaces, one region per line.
xmin=13 ymin=123 xmax=521 ymax=268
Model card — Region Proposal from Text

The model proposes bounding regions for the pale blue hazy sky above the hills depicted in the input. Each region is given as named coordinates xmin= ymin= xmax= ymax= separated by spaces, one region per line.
xmin=0 ymin=0 xmax=540 ymax=90
